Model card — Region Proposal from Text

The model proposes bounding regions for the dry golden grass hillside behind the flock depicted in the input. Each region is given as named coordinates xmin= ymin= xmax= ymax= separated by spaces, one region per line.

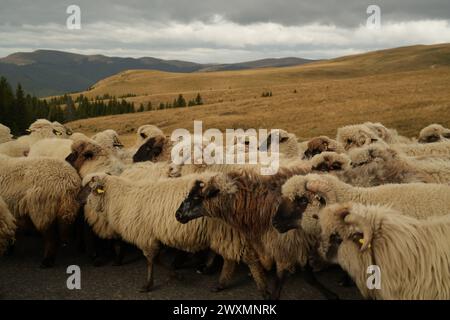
xmin=69 ymin=44 xmax=450 ymax=144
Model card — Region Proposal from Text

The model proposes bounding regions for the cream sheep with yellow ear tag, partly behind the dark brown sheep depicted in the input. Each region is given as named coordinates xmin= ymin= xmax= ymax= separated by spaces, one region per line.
xmin=80 ymin=173 xmax=268 ymax=297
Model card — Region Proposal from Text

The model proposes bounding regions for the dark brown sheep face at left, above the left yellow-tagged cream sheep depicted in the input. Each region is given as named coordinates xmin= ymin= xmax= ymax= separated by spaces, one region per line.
xmin=66 ymin=140 xmax=110 ymax=177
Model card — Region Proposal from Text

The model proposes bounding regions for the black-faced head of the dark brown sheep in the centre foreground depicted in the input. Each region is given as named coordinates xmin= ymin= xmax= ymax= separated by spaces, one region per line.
xmin=176 ymin=173 xmax=237 ymax=223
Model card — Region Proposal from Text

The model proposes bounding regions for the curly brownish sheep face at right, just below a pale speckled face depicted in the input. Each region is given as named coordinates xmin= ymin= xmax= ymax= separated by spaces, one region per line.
xmin=349 ymin=144 xmax=399 ymax=168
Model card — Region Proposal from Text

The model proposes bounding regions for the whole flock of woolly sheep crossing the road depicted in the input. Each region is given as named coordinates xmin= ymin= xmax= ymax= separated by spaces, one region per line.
xmin=0 ymin=119 xmax=450 ymax=299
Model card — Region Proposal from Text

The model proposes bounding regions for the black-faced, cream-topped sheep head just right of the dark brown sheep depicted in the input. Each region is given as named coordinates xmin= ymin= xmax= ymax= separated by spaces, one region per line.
xmin=272 ymin=174 xmax=334 ymax=233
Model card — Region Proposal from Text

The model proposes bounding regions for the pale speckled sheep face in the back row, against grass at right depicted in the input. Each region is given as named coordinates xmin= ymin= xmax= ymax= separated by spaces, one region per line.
xmin=337 ymin=125 xmax=380 ymax=151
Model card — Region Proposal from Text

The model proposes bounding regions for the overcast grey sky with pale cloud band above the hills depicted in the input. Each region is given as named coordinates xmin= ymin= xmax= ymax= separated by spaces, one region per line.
xmin=0 ymin=0 xmax=450 ymax=63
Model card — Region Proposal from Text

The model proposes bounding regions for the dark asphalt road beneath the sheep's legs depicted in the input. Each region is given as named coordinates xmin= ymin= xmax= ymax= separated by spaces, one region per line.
xmin=0 ymin=232 xmax=361 ymax=300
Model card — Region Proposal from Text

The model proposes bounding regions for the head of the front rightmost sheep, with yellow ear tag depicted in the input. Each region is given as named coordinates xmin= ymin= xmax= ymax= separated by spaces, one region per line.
xmin=318 ymin=203 xmax=373 ymax=263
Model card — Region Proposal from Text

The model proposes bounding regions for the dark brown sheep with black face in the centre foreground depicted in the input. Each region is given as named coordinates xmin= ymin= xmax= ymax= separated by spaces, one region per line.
xmin=176 ymin=166 xmax=336 ymax=299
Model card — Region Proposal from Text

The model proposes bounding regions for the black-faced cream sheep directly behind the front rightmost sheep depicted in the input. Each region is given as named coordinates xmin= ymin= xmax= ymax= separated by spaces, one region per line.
xmin=272 ymin=174 xmax=450 ymax=232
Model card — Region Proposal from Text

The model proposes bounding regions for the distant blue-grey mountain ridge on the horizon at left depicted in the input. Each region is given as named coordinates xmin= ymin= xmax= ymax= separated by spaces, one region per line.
xmin=0 ymin=50 xmax=312 ymax=96
